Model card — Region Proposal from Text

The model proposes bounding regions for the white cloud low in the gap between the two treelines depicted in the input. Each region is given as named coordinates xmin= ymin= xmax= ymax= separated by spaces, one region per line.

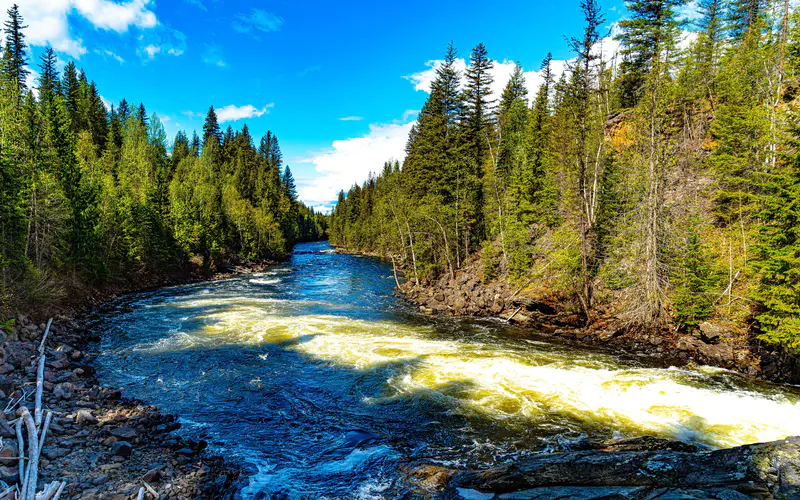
xmin=298 ymin=121 xmax=415 ymax=205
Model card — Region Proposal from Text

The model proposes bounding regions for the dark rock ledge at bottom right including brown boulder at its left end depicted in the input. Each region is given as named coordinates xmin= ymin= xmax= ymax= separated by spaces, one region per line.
xmin=406 ymin=437 xmax=800 ymax=500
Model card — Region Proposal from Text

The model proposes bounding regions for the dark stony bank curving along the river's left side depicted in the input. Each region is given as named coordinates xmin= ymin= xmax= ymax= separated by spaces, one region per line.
xmin=0 ymin=262 xmax=272 ymax=500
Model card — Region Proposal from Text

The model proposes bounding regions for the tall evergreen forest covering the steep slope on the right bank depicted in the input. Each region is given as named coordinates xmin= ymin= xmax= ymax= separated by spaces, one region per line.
xmin=331 ymin=0 xmax=800 ymax=348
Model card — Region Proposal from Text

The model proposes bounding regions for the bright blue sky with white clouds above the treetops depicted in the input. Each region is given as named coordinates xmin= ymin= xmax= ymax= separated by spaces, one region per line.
xmin=15 ymin=0 xmax=656 ymax=210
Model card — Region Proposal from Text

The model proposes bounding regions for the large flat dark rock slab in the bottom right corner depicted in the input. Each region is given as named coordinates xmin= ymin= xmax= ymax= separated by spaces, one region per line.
xmin=451 ymin=437 xmax=800 ymax=500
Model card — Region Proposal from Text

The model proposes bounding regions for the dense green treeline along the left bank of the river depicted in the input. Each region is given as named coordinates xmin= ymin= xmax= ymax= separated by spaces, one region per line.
xmin=0 ymin=6 xmax=326 ymax=311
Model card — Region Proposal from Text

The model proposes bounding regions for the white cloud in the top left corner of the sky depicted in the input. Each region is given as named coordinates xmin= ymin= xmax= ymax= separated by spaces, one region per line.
xmin=0 ymin=0 xmax=158 ymax=58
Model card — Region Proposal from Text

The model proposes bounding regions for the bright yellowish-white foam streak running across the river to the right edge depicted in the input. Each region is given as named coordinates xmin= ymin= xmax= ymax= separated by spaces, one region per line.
xmin=126 ymin=296 xmax=800 ymax=447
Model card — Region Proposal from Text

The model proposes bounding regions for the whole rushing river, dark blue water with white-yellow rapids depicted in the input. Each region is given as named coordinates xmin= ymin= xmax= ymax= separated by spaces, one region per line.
xmin=96 ymin=243 xmax=800 ymax=498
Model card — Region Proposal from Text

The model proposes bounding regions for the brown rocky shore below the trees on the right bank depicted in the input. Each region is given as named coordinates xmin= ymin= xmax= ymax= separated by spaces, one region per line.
xmin=402 ymin=266 xmax=800 ymax=384
